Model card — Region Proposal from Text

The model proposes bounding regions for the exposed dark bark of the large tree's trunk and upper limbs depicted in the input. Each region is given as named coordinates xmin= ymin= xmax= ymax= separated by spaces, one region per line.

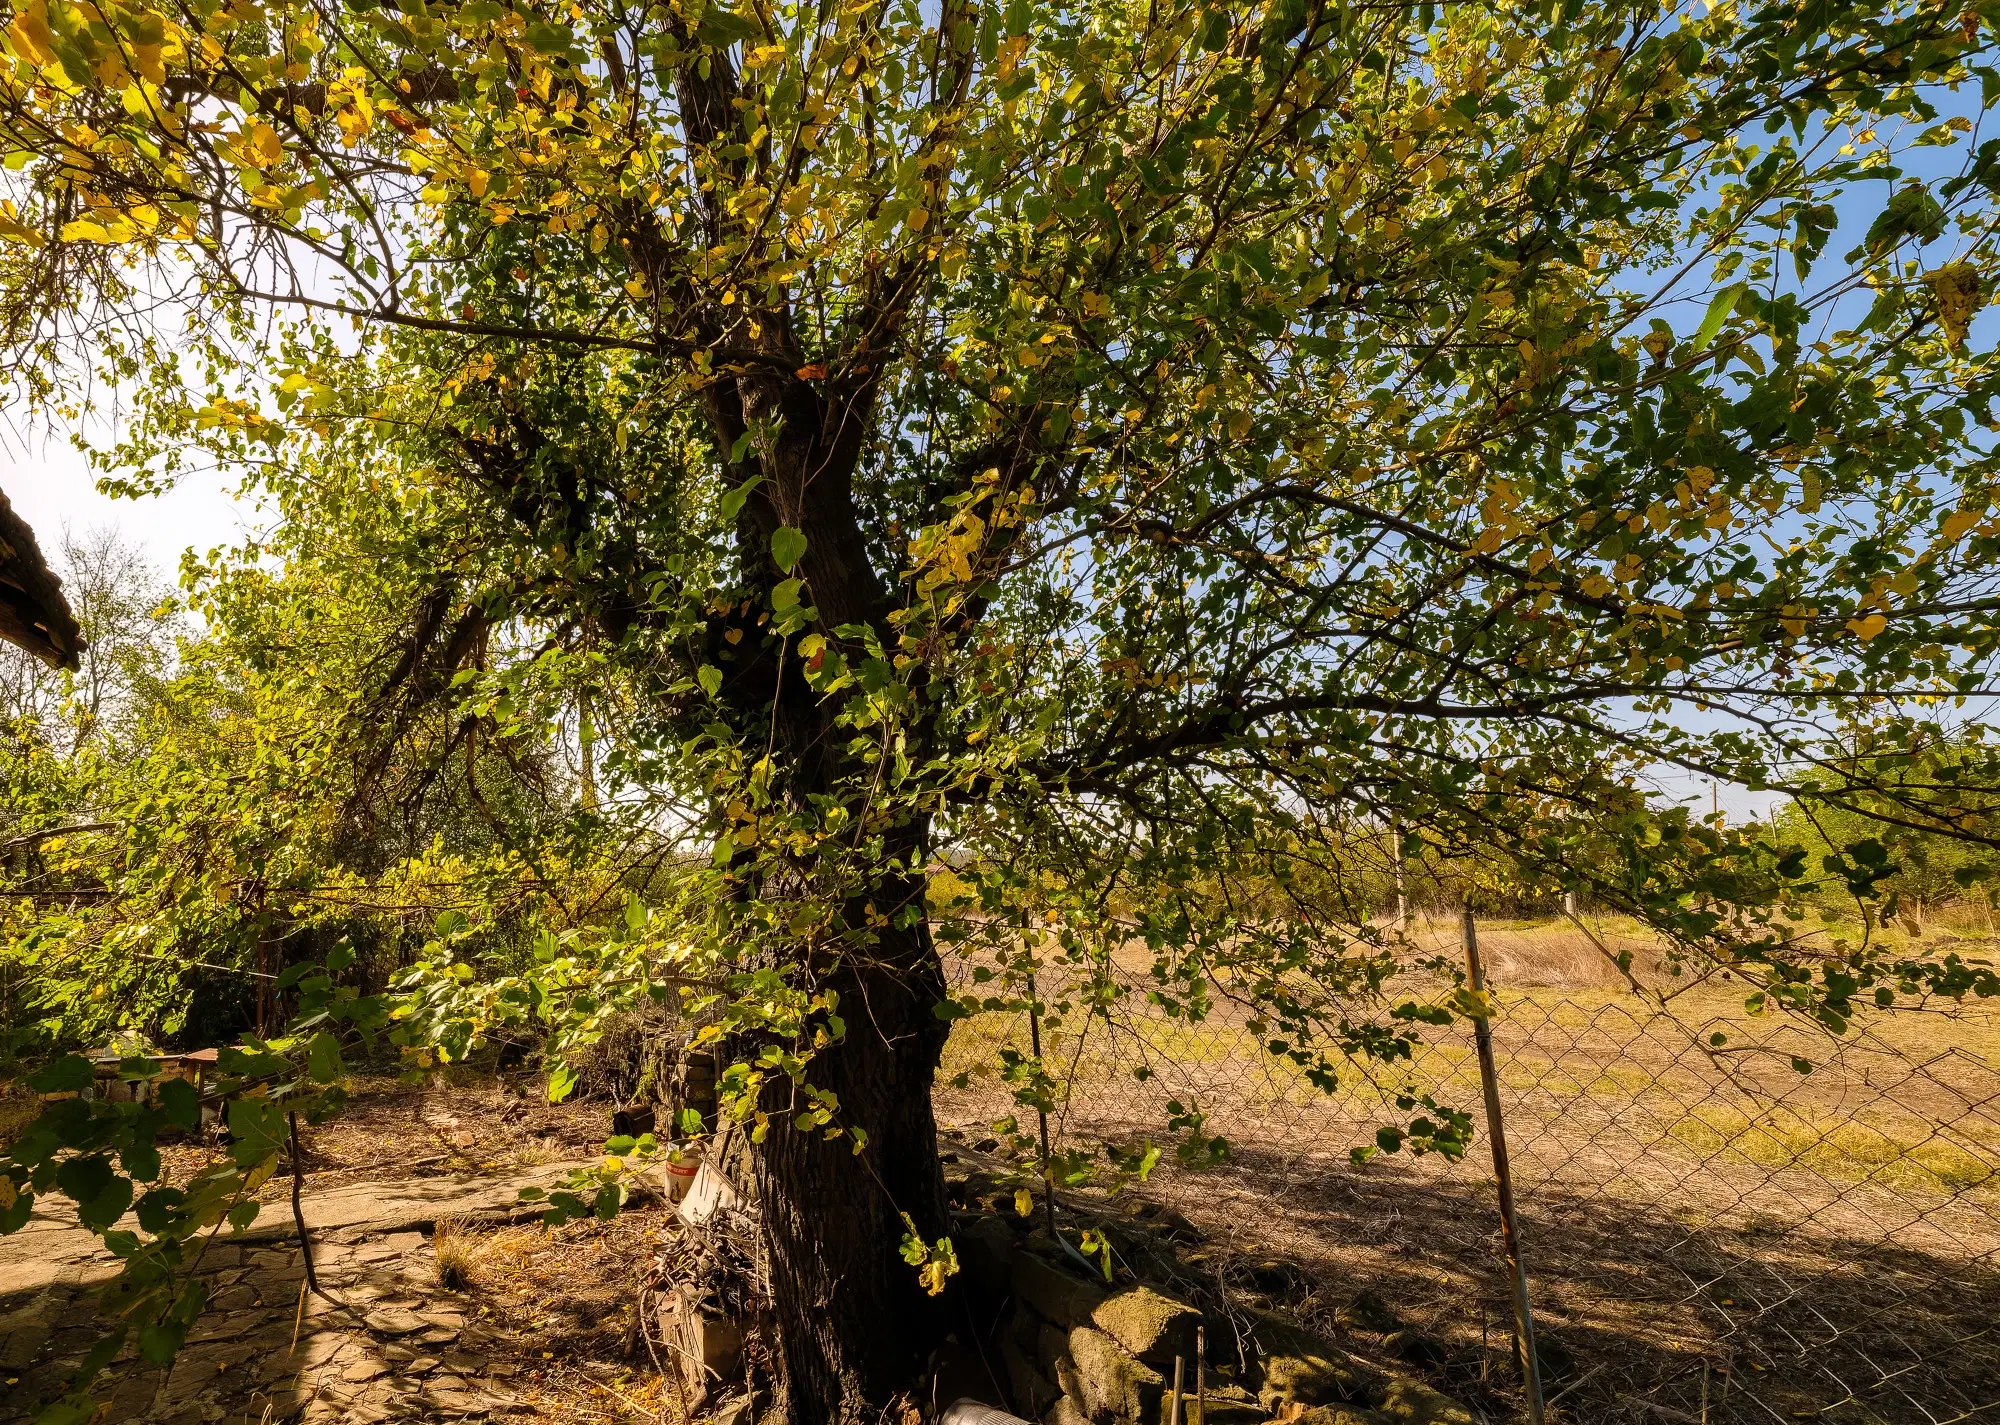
xmin=644 ymin=16 xmax=974 ymax=1425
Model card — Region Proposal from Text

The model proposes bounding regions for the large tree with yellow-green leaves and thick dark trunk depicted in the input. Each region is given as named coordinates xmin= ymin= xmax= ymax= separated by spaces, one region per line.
xmin=0 ymin=0 xmax=2000 ymax=1421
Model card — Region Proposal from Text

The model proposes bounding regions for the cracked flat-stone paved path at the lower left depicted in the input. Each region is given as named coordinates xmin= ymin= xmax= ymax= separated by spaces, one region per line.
xmin=0 ymin=1163 xmax=588 ymax=1425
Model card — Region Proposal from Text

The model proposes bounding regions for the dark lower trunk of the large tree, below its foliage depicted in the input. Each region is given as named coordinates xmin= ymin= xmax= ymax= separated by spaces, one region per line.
xmin=758 ymin=889 xmax=950 ymax=1425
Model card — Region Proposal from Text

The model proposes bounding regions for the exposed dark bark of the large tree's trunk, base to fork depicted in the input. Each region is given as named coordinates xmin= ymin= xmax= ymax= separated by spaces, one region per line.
xmin=710 ymin=356 xmax=968 ymax=1425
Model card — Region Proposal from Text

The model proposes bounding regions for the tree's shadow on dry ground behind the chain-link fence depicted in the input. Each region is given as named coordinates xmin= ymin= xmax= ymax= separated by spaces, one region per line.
xmin=1064 ymin=1121 xmax=2000 ymax=1425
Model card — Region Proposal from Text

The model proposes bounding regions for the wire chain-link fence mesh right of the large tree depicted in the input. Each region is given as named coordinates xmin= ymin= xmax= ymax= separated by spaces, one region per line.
xmin=938 ymin=921 xmax=2000 ymax=1425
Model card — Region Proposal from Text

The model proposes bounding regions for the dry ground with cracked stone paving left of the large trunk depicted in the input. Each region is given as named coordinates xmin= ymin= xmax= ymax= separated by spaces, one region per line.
xmin=0 ymin=1081 xmax=672 ymax=1425
